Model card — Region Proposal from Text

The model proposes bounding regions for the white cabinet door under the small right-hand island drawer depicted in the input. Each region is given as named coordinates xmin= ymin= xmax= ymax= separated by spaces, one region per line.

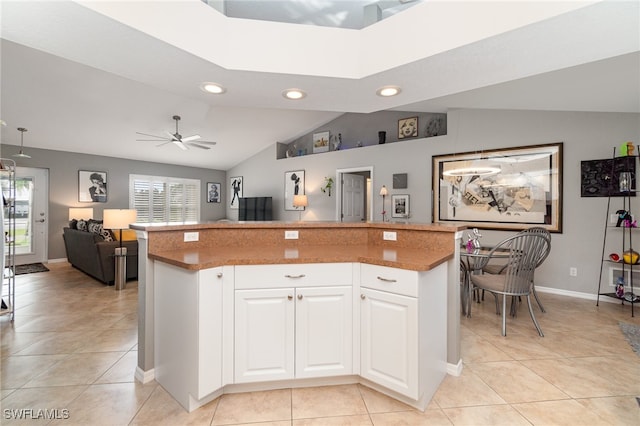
xmin=360 ymin=288 xmax=419 ymax=399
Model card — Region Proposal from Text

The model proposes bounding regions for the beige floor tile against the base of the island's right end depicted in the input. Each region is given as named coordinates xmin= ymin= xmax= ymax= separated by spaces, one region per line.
xmin=433 ymin=367 xmax=505 ymax=409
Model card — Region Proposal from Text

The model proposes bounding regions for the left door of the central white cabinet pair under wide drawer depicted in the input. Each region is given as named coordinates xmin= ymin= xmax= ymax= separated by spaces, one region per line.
xmin=235 ymin=288 xmax=295 ymax=383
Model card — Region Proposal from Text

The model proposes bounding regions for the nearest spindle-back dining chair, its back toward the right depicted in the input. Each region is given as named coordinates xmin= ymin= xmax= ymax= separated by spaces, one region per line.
xmin=470 ymin=231 xmax=550 ymax=337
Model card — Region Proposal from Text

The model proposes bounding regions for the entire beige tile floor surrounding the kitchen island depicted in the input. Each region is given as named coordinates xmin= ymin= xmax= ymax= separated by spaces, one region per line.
xmin=0 ymin=263 xmax=640 ymax=425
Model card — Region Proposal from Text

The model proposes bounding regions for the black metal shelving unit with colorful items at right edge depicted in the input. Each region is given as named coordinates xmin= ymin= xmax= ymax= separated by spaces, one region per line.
xmin=596 ymin=148 xmax=640 ymax=317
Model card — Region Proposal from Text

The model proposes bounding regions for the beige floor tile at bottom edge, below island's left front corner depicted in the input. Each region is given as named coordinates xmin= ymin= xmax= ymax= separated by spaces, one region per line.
xmin=130 ymin=386 xmax=219 ymax=426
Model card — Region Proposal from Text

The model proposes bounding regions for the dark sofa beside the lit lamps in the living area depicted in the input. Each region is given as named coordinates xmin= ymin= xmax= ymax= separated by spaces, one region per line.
xmin=62 ymin=228 xmax=138 ymax=284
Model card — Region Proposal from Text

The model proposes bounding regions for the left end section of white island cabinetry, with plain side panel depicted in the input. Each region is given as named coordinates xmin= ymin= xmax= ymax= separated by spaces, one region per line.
xmin=154 ymin=262 xmax=226 ymax=411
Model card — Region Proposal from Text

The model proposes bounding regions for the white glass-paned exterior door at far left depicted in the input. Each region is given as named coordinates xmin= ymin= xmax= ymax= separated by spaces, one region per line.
xmin=15 ymin=167 xmax=49 ymax=265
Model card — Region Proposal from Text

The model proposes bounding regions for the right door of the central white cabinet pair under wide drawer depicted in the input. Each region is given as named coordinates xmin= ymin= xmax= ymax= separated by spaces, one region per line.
xmin=295 ymin=286 xmax=353 ymax=378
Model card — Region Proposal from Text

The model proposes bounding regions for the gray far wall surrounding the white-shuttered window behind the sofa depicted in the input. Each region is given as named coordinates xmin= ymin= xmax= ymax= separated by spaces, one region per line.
xmin=2 ymin=144 xmax=227 ymax=259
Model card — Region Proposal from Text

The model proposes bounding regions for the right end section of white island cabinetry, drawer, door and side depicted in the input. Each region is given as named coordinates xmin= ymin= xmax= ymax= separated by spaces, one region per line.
xmin=360 ymin=264 xmax=446 ymax=401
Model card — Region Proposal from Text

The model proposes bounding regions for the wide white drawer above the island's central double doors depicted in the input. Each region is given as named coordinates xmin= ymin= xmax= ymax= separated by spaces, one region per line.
xmin=235 ymin=263 xmax=353 ymax=289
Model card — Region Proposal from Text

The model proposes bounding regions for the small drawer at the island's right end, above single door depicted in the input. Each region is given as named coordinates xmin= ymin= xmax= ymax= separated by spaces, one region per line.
xmin=360 ymin=263 xmax=418 ymax=297
